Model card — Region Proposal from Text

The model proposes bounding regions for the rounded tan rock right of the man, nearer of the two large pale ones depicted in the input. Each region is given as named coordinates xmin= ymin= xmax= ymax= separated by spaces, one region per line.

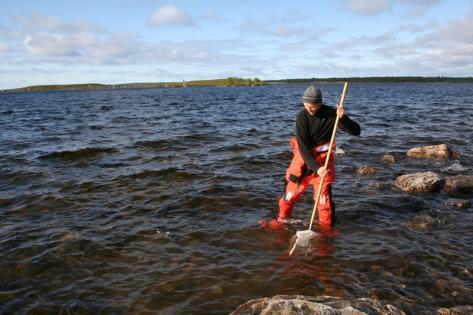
xmin=394 ymin=172 xmax=440 ymax=193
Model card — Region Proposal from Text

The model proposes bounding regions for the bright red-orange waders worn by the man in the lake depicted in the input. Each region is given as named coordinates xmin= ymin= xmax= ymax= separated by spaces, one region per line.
xmin=278 ymin=138 xmax=335 ymax=226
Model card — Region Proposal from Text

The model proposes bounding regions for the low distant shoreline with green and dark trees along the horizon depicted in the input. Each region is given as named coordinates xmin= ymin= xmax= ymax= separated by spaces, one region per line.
xmin=0 ymin=76 xmax=473 ymax=92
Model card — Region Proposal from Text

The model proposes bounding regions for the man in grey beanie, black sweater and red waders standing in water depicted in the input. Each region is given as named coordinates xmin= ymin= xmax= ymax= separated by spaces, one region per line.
xmin=271 ymin=85 xmax=360 ymax=227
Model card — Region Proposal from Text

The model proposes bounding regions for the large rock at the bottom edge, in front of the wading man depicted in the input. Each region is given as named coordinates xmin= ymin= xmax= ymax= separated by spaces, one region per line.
xmin=231 ymin=295 xmax=405 ymax=315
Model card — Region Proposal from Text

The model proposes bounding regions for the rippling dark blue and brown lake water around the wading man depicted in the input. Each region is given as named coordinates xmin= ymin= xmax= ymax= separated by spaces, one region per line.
xmin=0 ymin=84 xmax=473 ymax=314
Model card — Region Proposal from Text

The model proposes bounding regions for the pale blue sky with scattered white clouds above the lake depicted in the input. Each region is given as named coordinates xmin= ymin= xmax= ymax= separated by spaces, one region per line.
xmin=0 ymin=0 xmax=473 ymax=89
